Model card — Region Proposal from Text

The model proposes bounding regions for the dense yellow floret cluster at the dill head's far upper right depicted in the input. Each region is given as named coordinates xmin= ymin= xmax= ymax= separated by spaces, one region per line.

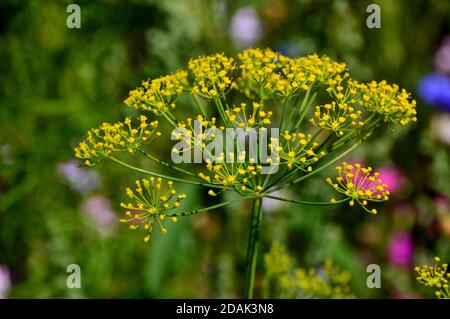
xmin=361 ymin=81 xmax=417 ymax=126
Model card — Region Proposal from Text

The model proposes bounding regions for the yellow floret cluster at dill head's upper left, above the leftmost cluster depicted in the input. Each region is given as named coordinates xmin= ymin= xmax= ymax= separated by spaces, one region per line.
xmin=124 ymin=70 xmax=188 ymax=115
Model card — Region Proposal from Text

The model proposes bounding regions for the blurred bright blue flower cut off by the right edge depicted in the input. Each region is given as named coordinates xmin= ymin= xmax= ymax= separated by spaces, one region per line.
xmin=418 ymin=73 xmax=450 ymax=112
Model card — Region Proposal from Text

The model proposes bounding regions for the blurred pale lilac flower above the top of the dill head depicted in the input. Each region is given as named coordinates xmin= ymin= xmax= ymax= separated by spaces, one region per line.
xmin=230 ymin=7 xmax=263 ymax=48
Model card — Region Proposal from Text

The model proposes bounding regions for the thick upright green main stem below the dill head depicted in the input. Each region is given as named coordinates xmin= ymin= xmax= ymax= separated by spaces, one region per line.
xmin=244 ymin=198 xmax=262 ymax=299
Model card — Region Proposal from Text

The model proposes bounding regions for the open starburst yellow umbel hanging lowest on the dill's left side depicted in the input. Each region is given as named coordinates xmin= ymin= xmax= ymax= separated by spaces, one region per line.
xmin=120 ymin=177 xmax=186 ymax=242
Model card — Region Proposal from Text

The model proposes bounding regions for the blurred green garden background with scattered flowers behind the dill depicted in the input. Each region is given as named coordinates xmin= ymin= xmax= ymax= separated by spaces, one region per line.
xmin=0 ymin=0 xmax=450 ymax=298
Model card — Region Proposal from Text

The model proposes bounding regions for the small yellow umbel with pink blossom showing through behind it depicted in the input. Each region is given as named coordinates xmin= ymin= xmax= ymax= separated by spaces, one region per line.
xmin=326 ymin=162 xmax=389 ymax=214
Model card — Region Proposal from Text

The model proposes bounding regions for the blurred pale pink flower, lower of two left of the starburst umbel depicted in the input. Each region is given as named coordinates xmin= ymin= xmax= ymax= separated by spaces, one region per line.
xmin=82 ymin=195 xmax=117 ymax=236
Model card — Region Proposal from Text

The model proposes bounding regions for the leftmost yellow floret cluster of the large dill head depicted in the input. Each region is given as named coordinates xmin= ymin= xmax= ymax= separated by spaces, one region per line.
xmin=75 ymin=115 xmax=161 ymax=166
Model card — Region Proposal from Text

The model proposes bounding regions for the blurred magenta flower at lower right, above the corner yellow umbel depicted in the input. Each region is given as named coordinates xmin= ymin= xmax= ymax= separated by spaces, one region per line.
xmin=387 ymin=232 xmax=414 ymax=267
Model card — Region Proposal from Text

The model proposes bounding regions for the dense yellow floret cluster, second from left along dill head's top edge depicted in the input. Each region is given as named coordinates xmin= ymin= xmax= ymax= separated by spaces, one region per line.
xmin=188 ymin=53 xmax=235 ymax=99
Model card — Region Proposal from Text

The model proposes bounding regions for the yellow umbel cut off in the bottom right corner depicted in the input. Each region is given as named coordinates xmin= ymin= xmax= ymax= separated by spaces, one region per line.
xmin=414 ymin=257 xmax=450 ymax=299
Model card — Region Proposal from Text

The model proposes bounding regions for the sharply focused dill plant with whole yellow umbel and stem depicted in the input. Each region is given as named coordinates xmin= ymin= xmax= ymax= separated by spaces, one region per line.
xmin=75 ymin=49 xmax=416 ymax=298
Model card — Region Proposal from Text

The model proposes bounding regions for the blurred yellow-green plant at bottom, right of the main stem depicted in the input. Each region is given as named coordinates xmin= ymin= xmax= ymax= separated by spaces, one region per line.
xmin=263 ymin=241 xmax=355 ymax=299
